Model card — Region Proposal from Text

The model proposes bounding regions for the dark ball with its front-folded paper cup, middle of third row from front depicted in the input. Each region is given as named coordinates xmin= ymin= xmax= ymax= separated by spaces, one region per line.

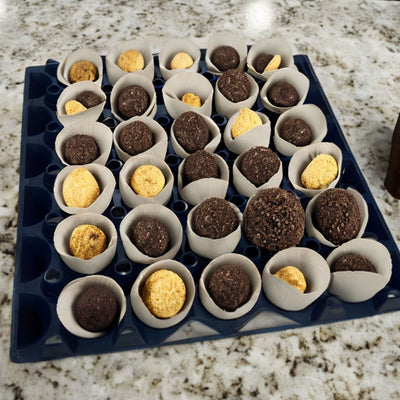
xmin=178 ymin=150 xmax=229 ymax=205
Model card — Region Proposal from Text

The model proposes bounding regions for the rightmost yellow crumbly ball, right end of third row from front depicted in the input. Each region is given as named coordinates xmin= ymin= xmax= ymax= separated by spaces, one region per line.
xmin=301 ymin=154 xmax=338 ymax=189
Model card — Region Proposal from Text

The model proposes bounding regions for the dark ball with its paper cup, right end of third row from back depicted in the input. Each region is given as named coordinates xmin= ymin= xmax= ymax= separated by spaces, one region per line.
xmin=273 ymin=104 xmax=328 ymax=157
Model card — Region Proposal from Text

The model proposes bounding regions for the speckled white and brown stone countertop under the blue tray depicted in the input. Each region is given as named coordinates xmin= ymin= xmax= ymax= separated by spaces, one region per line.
xmin=0 ymin=0 xmax=400 ymax=400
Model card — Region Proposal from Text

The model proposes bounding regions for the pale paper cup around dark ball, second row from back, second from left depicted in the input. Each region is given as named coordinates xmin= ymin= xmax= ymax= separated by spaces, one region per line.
xmin=110 ymin=74 xmax=157 ymax=122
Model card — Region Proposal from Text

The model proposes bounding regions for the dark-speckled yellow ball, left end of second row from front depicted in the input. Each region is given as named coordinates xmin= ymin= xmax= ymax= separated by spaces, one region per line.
xmin=69 ymin=225 xmax=107 ymax=260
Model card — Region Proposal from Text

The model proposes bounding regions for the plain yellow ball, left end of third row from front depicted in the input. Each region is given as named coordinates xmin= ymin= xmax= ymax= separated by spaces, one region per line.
xmin=62 ymin=167 xmax=100 ymax=208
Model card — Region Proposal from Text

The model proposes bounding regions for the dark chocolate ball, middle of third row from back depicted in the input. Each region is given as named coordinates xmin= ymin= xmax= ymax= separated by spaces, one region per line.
xmin=173 ymin=111 xmax=210 ymax=153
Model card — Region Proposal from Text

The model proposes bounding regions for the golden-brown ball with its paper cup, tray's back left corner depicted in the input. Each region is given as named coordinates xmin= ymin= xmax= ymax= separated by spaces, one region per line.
xmin=57 ymin=48 xmax=103 ymax=86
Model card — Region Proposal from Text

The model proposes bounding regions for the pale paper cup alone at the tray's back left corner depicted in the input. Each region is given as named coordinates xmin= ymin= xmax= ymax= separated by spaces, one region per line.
xmin=57 ymin=48 xmax=103 ymax=86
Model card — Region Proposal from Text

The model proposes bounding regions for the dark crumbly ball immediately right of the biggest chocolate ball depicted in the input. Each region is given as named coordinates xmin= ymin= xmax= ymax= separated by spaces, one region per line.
xmin=313 ymin=188 xmax=361 ymax=244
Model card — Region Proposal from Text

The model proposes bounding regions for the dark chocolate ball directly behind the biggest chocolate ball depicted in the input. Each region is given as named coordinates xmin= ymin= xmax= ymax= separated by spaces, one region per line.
xmin=238 ymin=146 xmax=280 ymax=187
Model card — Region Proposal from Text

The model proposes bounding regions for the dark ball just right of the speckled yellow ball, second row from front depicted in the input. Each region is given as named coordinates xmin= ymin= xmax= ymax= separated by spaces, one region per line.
xmin=132 ymin=217 xmax=169 ymax=257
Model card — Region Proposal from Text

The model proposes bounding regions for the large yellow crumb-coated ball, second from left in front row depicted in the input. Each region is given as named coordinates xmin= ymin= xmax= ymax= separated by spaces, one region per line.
xmin=141 ymin=269 xmax=186 ymax=318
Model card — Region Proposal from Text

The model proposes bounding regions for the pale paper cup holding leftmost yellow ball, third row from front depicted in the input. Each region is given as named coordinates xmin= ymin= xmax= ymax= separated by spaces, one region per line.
xmin=54 ymin=163 xmax=116 ymax=214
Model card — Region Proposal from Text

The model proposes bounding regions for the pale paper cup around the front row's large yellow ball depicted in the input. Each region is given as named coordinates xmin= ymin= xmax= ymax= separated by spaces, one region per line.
xmin=131 ymin=260 xmax=196 ymax=329
